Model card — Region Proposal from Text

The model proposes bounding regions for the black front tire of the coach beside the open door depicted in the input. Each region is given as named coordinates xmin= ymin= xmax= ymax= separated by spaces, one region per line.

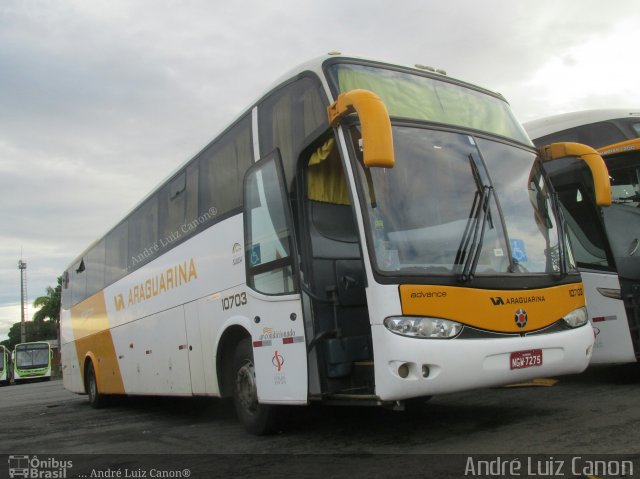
xmin=233 ymin=338 xmax=279 ymax=436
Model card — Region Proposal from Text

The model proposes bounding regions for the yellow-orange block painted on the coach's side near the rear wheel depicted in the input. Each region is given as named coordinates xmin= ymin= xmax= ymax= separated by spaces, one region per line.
xmin=71 ymin=291 xmax=125 ymax=394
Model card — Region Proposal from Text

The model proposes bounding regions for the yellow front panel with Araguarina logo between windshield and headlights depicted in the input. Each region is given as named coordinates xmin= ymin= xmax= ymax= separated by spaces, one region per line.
xmin=400 ymin=283 xmax=585 ymax=333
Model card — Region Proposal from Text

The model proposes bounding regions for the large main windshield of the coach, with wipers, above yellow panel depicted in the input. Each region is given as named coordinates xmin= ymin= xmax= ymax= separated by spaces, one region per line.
xmin=352 ymin=125 xmax=575 ymax=279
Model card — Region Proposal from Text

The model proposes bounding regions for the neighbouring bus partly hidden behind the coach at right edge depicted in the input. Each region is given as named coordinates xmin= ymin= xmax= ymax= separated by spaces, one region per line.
xmin=525 ymin=110 xmax=640 ymax=364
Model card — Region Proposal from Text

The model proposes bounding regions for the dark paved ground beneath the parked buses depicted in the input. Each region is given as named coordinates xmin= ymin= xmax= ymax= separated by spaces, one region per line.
xmin=0 ymin=364 xmax=640 ymax=477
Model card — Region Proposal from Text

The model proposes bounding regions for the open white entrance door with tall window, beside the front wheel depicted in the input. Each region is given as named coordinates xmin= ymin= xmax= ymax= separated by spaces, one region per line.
xmin=244 ymin=150 xmax=307 ymax=404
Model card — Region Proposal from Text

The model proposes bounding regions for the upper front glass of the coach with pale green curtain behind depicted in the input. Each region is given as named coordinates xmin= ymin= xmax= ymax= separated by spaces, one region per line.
xmin=328 ymin=63 xmax=531 ymax=145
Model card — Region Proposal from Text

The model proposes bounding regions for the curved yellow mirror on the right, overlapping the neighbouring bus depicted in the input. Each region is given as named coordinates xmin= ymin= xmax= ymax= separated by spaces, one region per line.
xmin=538 ymin=142 xmax=611 ymax=206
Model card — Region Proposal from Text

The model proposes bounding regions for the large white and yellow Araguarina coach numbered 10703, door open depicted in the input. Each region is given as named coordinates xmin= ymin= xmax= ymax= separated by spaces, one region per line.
xmin=61 ymin=55 xmax=609 ymax=433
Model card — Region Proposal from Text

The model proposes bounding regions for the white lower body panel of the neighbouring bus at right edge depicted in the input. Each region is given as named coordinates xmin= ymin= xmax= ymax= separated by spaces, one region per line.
xmin=580 ymin=271 xmax=636 ymax=364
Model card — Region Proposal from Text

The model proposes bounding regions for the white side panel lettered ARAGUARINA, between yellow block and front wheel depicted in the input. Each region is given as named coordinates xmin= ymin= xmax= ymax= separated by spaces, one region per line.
xmin=105 ymin=215 xmax=248 ymax=395
